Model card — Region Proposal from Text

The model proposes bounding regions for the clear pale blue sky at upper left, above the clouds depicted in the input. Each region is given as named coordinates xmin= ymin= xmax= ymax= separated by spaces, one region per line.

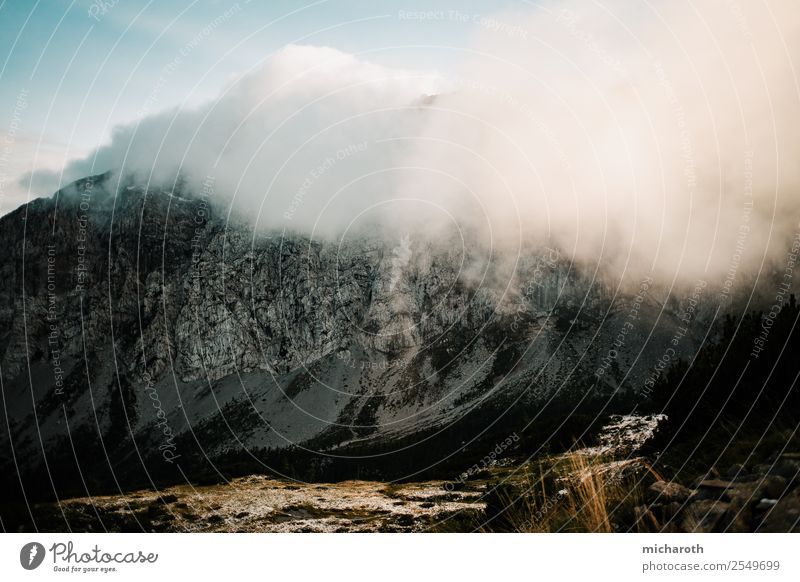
xmin=0 ymin=0 xmax=533 ymax=214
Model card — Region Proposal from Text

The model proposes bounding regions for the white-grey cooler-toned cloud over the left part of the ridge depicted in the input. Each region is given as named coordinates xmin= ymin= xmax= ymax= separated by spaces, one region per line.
xmin=52 ymin=45 xmax=438 ymax=232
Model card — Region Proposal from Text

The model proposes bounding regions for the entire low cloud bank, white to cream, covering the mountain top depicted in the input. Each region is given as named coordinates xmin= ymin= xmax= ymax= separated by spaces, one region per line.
xmin=36 ymin=0 xmax=800 ymax=288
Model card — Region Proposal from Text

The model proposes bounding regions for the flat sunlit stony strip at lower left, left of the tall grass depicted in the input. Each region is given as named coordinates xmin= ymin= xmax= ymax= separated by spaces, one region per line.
xmin=25 ymin=476 xmax=485 ymax=533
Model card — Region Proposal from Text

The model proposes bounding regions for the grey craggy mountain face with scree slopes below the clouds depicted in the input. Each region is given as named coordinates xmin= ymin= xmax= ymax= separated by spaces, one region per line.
xmin=0 ymin=175 xmax=708 ymax=496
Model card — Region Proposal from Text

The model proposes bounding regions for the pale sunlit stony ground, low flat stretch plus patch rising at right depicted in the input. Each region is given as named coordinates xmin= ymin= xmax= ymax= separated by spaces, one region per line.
xmin=20 ymin=416 xmax=660 ymax=532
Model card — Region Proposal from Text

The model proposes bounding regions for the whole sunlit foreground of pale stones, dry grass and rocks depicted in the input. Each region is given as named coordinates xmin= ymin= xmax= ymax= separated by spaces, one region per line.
xmin=9 ymin=406 xmax=800 ymax=533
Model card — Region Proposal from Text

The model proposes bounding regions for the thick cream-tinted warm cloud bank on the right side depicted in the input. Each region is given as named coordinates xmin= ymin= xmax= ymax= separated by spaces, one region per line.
xmin=408 ymin=2 xmax=800 ymax=278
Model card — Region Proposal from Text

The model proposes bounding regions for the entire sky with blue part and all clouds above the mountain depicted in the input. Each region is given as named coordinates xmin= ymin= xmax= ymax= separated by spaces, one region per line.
xmin=0 ymin=0 xmax=800 ymax=282
